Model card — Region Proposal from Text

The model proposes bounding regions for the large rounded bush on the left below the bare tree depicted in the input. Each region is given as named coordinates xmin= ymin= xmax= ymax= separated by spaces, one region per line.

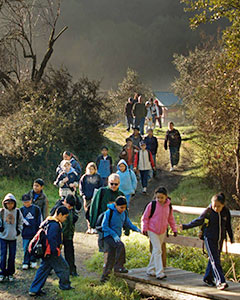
xmin=0 ymin=69 xmax=109 ymax=178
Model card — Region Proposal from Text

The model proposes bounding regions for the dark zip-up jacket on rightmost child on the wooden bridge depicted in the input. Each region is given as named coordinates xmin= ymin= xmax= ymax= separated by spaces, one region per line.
xmin=183 ymin=205 xmax=233 ymax=243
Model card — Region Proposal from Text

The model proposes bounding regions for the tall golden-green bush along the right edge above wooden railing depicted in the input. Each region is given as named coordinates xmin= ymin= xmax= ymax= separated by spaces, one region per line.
xmin=173 ymin=45 xmax=240 ymax=207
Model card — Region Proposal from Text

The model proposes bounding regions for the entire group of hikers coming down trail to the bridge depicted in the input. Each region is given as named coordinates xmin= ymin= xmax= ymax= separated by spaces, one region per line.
xmin=0 ymin=94 xmax=234 ymax=296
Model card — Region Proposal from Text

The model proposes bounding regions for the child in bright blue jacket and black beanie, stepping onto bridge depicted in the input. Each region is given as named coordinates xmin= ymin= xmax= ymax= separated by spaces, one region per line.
xmin=101 ymin=196 xmax=141 ymax=282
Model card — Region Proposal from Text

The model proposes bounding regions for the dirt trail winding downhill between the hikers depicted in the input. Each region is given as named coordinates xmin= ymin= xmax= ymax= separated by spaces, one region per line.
xmin=0 ymin=140 xmax=191 ymax=300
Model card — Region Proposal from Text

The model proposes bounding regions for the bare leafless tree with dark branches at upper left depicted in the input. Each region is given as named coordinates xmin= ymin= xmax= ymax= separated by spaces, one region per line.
xmin=0 ymin=0 xmax=67 ymax=89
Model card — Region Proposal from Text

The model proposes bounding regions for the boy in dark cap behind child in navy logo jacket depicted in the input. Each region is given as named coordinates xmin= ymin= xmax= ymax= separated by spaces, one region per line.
xmin=27 ymin=178 xmax=48 ymax=220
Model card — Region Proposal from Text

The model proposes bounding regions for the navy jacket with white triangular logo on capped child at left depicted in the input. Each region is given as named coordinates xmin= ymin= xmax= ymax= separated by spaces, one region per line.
xmin=20 ymin=204 xmax=42 ymax=239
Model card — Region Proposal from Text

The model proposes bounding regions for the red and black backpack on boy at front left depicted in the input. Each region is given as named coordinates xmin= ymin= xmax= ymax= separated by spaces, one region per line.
xmin=28 ymin=222 xmax=49 ymax=258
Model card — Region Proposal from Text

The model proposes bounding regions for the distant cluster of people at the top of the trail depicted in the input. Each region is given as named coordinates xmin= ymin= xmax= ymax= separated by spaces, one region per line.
xmin=125 ymin=93 xmax=163 ymax=135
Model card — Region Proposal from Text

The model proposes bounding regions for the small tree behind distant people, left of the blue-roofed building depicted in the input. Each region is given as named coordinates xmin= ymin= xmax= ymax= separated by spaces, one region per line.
xmin=108 ymin=68 xmax=152 ymax=120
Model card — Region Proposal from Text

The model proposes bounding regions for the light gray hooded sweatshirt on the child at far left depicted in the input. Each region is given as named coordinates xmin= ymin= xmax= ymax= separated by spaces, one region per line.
xmin=0 ymin=193 xmax=23 ymax=241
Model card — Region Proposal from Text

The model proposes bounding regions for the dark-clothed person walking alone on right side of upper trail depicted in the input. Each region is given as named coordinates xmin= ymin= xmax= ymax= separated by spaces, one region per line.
xmin=164 ymin=122 xmax=182 ymax=172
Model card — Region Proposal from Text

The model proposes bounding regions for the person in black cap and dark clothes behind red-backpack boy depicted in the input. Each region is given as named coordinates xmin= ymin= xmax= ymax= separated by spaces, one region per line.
xmin=50 ymin=195 xmax=78 ymax=276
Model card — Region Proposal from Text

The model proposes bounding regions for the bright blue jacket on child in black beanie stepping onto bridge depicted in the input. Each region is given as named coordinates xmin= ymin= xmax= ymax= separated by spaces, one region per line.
xmin=102 ymin=203 xmax=141 ymax=238
